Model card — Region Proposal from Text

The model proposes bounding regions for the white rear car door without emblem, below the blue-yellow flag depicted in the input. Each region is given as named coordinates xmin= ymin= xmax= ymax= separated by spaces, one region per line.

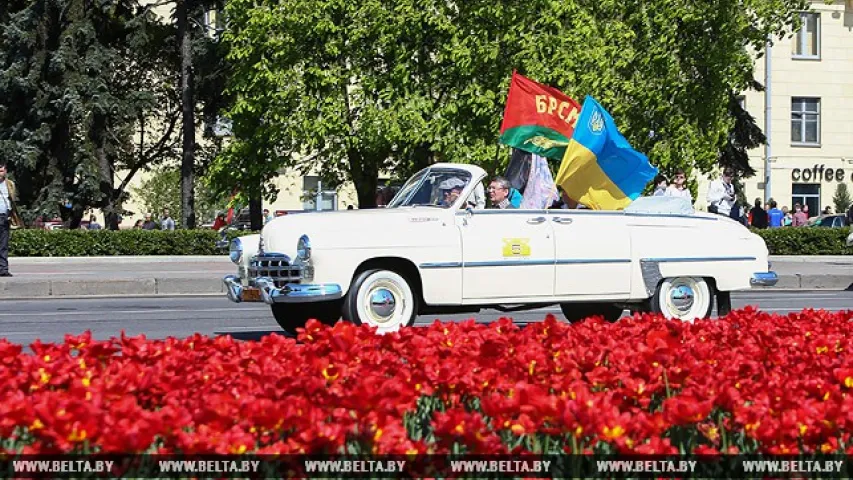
xmin=549 ymin=210 xmax=631 ymax=300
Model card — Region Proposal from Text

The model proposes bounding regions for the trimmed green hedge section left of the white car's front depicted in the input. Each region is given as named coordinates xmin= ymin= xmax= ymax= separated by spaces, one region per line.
xmin=9 ymin=230 xmax=256 ymax=257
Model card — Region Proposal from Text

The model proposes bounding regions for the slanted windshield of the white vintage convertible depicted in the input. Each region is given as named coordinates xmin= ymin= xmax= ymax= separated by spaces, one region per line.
xmin=388 ymin=168 xmax=471 ymax=208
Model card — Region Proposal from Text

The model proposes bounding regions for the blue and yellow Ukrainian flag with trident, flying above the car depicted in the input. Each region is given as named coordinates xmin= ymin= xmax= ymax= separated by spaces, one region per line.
xmin=554 ymin=95 xmax=658 ymax=210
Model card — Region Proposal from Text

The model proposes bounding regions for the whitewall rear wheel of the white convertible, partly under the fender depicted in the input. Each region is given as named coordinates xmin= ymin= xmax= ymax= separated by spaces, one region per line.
xmin=651 ymin=277 xmax=714 ymax=322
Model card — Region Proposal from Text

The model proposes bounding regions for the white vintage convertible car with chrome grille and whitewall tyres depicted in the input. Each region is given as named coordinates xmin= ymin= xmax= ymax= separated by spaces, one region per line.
xmin=223 ymin=164 xmax=777 ymax=332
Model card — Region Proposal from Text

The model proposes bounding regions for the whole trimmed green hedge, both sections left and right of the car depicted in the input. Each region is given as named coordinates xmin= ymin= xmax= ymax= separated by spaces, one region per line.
xmin=9 ymin=227 xmax=853 ymax=257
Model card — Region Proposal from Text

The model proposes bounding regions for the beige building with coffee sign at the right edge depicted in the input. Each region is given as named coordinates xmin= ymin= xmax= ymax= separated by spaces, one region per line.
xmin=696 ymin=0 xmax=853 ymax=216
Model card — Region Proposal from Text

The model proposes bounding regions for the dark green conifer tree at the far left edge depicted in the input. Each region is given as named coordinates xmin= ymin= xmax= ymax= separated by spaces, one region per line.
xmin=0 ymin=0 xmax=176 ymax=228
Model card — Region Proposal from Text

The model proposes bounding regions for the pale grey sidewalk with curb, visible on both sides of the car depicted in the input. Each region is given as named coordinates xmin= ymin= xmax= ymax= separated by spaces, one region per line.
xmin=0 ymin=255 xmax=853 ymax=299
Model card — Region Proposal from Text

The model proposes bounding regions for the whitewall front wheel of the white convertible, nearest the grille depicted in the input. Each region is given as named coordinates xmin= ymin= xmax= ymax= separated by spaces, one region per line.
xmin=343 ymin=269 xmax=418 ymax=333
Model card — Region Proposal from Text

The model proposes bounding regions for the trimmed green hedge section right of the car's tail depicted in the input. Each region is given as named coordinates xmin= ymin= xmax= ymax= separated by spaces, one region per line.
xmin=753 ymin=227 xmax=853 ymax=255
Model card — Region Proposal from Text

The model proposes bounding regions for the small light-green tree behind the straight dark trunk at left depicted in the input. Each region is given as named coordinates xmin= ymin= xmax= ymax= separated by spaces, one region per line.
xmin=131 ymin=167 xmax=228 ymax=227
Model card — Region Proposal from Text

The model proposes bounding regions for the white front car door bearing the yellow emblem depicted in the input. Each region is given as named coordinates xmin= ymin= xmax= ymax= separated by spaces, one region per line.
xmin=456 ymin=209 xmax=554 ymax=301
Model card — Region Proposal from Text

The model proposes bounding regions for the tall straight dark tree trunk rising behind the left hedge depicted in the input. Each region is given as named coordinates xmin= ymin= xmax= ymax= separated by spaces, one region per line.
xmin=177 ymin=0 xmax=195 ymax=228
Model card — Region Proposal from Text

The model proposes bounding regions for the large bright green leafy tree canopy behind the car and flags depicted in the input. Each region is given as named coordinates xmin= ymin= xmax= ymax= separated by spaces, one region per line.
xmin=211 ymin=0 xmax=806 ymax=208
